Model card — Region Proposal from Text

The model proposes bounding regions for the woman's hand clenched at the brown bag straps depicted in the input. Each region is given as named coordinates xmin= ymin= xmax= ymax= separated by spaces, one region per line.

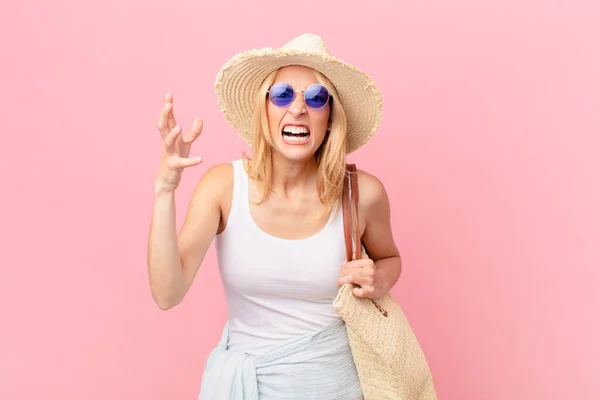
xmin=338 ymin=254 xmax=389 ymax=299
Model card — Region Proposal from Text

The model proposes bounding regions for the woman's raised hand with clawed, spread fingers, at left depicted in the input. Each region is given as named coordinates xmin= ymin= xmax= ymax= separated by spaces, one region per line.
xmin=155 ymin=93 xmax=202 ymax=191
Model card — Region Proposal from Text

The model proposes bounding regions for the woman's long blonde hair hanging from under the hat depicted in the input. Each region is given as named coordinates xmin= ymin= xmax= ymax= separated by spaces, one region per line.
xmin=243 ymin=70 xmax=347 ymax=219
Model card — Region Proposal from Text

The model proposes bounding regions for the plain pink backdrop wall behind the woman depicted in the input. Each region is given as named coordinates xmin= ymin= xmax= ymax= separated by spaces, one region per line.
xmin=0 ymin=0 xmax=600 ymax=400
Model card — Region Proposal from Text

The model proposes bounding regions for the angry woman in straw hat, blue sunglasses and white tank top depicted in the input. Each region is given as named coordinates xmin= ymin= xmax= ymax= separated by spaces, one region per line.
xmin=148 ymin=34 xmax=401 ymax=400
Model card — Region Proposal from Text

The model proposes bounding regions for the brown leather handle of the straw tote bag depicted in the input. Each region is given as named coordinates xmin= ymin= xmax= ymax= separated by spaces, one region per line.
xmin=342 ymin=164 xmax=362 ymax=261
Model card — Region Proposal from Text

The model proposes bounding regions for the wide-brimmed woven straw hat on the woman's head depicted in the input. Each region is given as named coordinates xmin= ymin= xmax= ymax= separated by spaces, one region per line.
xmin=215 ymin=33 xmax=383 ymax=153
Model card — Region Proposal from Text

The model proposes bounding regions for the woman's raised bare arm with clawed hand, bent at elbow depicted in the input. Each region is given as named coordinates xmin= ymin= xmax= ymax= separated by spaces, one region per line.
xmin=147 ymin=94 xmax=228 ymax=310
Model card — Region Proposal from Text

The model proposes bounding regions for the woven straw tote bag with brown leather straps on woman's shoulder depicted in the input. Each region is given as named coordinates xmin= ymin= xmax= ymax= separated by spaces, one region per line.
xmin=333 ymin=164 xmax=437 ymax=400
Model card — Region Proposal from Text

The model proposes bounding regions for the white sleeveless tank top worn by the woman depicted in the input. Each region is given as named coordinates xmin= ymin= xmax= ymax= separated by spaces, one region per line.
xmin=215 ymin=160 xmax=345 ymax=356
